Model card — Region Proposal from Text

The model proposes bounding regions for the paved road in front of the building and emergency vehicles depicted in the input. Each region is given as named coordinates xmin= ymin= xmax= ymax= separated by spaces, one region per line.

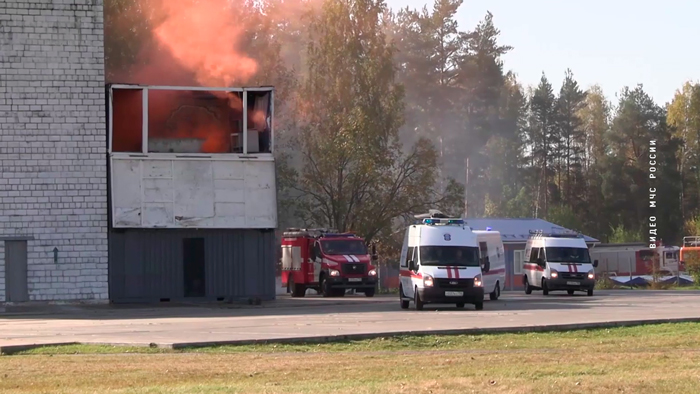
xmin=0 ymin=291 xmax=700 ymax=346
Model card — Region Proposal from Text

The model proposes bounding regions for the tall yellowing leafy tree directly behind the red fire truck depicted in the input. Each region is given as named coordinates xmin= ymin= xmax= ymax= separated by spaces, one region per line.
xmin=285 ymin=0 xmax=462 ymax=240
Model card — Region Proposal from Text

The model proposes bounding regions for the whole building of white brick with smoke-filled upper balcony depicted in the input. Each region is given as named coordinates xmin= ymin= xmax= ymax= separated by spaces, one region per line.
xmin=0 ymin=0 xmax=277 ymax=302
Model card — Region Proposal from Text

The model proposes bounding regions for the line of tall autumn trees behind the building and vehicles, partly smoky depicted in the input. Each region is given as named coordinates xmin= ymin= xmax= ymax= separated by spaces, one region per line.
xmin=105 ymin=0 xmax=700 ymax=252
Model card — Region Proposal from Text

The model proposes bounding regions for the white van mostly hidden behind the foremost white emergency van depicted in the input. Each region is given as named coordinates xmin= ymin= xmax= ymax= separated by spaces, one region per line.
xmin=474 ymin=230 xmax=506 ymax=300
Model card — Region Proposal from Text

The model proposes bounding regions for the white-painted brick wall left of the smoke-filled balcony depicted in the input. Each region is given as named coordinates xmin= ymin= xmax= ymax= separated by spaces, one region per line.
xmin=0 ymin=0 xmax=108 ymax=302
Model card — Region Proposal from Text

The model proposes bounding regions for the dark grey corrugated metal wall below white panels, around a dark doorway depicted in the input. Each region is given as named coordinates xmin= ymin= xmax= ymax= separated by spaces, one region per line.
xmin=109 ymin=229 xmax=277 ymax=302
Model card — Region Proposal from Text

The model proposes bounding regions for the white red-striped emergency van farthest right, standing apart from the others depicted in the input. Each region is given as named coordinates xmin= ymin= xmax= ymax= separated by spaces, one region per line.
xmin=523 ymin=231 xmax=598 ymax=296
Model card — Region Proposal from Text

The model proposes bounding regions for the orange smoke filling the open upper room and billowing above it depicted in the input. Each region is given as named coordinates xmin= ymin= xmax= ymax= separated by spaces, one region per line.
xmin=108 ymin=0 xmax=282 ymax=153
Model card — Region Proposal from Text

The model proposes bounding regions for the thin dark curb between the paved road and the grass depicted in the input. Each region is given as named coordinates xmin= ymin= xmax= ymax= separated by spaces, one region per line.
xmin=0 ymin=317 xmax=700 ymax=355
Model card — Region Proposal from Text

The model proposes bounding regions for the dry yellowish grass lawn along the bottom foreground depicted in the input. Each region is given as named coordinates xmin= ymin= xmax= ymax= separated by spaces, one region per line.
xmin=0 ymin=323 xmax=700 ymax=394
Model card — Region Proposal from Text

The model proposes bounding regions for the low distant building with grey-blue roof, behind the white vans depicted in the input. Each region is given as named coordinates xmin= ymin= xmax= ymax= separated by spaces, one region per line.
xmin=466 ymin=218 xmax=600 ymax=290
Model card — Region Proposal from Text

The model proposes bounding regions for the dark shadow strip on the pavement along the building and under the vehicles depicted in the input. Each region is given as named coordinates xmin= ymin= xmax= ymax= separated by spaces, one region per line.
xmin=0 ymin=291 xmax=668 ymax=321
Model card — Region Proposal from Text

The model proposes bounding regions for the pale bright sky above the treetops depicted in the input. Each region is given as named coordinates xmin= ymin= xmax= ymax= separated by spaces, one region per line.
xmin=386 ymin=0 xmax=700 ymax=105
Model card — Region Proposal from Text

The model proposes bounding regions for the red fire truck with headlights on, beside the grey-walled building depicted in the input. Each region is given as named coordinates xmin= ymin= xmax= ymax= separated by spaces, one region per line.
xmin=282 ymin=228 xmax=377 ymax=297
